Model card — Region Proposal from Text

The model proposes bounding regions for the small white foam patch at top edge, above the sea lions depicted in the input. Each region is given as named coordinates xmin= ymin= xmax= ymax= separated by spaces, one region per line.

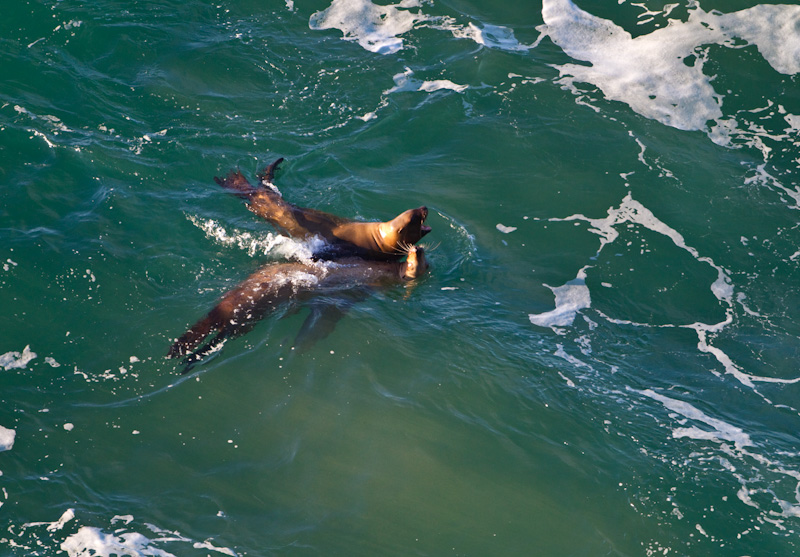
xmin=308 ymin=0 xmax=428 ymax=54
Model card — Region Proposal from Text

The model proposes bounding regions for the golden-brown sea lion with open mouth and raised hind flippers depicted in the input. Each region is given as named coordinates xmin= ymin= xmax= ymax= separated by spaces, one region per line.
xmin=214 ymin=158 xmax=431 ymax=260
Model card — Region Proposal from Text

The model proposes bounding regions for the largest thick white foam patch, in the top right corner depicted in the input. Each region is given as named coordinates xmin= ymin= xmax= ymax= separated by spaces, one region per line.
xmin=541 ymin=0 xmax=800 ymax=137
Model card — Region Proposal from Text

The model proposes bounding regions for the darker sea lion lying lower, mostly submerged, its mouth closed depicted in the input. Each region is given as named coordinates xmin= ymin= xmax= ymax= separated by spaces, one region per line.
xmin=167 ymin=246 xmax=428 ymax=366
